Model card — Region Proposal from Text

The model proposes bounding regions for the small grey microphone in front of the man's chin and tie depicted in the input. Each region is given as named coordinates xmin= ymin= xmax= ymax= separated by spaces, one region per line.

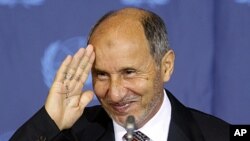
xmin=125 ymin=115 xmax=135 ymax=141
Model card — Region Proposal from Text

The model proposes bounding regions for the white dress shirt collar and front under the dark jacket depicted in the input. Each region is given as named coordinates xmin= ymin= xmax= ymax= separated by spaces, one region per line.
xmin=113 ymin=90 xmax=171 ymax=141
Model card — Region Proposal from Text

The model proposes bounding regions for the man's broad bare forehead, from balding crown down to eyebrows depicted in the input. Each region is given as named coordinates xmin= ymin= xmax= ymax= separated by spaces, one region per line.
xmin=90 ymin=17 xmax=151 ymax=69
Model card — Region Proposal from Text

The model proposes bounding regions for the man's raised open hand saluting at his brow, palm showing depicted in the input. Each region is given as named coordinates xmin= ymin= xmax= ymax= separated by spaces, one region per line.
xmin=45 ymin=45 xmax=95 ymax=130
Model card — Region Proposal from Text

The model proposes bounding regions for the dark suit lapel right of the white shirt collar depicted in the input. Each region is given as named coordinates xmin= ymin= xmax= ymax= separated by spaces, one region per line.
xmin=166 ymin=90 xmax=204 ymax=141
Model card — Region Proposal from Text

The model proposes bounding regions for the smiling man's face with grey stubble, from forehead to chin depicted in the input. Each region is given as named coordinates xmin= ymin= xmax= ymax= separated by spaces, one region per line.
xmin=91 ymin=19 xmax=163 ymax=127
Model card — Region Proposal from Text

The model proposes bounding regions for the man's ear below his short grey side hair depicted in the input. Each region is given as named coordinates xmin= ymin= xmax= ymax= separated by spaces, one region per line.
xmin=161 ymin=50 xmax=175 ymax=82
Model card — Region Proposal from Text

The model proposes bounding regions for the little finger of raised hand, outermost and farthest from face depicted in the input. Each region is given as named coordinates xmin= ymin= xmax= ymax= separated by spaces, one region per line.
xmin=55 ymin=55 xmax=72 ymax=82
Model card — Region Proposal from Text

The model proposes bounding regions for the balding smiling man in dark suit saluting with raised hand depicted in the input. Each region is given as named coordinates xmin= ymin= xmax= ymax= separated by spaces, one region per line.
xmin=11 ymin=8 xmax=229 ymax=141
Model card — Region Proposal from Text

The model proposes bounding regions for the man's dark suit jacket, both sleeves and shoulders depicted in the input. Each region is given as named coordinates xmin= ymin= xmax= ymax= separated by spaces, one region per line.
xmin=10 ymin=90 xmax=229 ymax=141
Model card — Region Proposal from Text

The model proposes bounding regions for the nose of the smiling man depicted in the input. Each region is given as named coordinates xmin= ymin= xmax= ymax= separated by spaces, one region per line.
xmin=108 ymin=77 xmax=127 ymax=102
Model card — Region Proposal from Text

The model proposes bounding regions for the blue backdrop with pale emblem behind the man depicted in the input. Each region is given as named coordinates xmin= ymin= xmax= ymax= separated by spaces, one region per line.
xmin=0 ymin=0 xmax=250 ymax=141
